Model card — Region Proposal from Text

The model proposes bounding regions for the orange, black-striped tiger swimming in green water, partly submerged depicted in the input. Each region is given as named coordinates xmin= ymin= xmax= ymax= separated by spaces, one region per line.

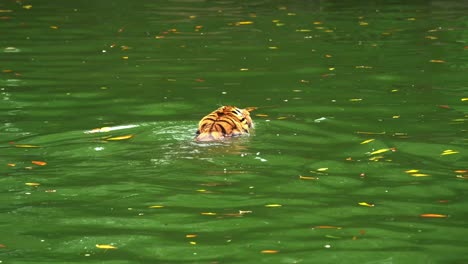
xmin=195 ymin=106 xmax=255 ymax=141
